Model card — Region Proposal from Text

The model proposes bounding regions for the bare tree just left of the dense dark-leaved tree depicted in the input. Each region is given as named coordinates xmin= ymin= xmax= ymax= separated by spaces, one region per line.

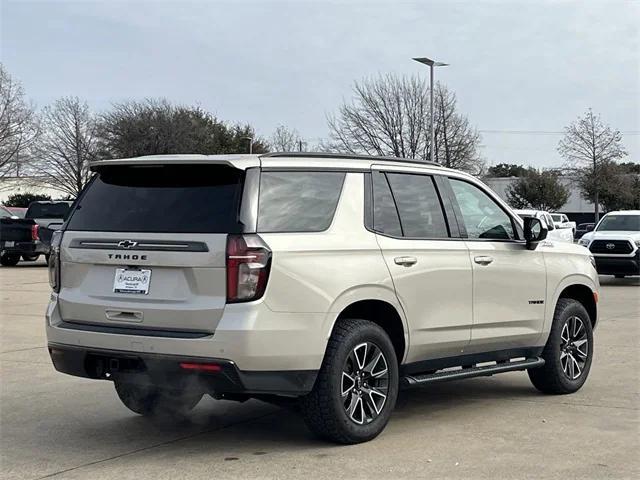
xmin=34 ymin=97 xmax=97 ymax=197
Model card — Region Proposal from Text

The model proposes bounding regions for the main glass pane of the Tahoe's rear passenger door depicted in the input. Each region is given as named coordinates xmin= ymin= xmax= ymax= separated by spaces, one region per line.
xmin=387 ymin=173 xmax=449 ymax=238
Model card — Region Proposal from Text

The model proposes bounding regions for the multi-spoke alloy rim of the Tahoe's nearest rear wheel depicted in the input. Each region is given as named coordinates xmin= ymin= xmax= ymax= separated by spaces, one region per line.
xmin=340 ymin=342 xmax=389 ymax=425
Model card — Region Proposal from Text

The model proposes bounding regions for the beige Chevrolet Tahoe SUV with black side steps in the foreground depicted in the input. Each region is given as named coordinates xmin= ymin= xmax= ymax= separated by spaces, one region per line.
xmin=46 ymin=154 xmax=599 ymax=443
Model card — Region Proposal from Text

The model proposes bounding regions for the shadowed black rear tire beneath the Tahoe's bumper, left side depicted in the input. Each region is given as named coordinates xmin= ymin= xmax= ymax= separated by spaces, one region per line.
xmin=114 ymin=381 xmax=203 ymax=416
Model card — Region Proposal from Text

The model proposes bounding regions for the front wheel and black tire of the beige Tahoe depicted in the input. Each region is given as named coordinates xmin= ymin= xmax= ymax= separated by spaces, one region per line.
xmin=528 ymin=298 xmax=593 ymax=395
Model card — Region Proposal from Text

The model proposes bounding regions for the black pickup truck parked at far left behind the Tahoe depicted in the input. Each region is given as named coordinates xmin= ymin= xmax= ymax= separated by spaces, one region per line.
xmin=0 ymin=201 xmax=71 ymax=267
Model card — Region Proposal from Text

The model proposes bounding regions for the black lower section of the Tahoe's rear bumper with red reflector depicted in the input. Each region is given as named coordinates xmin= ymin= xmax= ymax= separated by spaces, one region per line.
xmin=49 ymin=342 xmax=317 ymax=397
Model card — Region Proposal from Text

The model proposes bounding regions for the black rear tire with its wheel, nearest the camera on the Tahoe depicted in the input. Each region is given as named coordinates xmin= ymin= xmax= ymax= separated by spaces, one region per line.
xmin=300 ymin=319 xmax=399 ymax=444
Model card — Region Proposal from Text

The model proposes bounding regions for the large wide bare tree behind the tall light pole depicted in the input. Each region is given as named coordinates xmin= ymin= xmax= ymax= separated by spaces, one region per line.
xmin=324 ymin=75 xmax=482 ymax=171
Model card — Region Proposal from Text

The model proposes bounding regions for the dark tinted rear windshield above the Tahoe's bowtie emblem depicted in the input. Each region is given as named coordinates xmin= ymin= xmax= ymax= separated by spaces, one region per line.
xmin=67 ymin=165 xmax=243 ymax=233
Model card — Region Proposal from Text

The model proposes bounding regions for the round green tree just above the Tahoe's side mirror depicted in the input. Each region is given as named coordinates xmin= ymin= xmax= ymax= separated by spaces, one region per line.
xmin=507 ymin=170 xmax=569 ymax=211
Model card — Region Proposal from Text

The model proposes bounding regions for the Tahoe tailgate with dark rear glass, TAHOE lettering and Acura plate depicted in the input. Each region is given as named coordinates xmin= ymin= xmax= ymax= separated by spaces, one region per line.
xmin=58 ymin=165 xmax=244 ymax=334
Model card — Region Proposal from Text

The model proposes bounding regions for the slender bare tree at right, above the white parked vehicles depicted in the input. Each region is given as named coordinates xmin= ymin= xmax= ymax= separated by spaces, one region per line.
xmin=558 ymin=109 xmax=627 ymax=222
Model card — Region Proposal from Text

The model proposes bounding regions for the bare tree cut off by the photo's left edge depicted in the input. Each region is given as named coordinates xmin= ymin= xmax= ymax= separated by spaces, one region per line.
xmin=0 ymin=63 xmax=37 ymax=179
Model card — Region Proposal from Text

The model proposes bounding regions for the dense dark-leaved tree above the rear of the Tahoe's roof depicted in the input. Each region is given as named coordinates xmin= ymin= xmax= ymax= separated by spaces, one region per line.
xmin=98 ymin=99 xmax=267 ymax=158
